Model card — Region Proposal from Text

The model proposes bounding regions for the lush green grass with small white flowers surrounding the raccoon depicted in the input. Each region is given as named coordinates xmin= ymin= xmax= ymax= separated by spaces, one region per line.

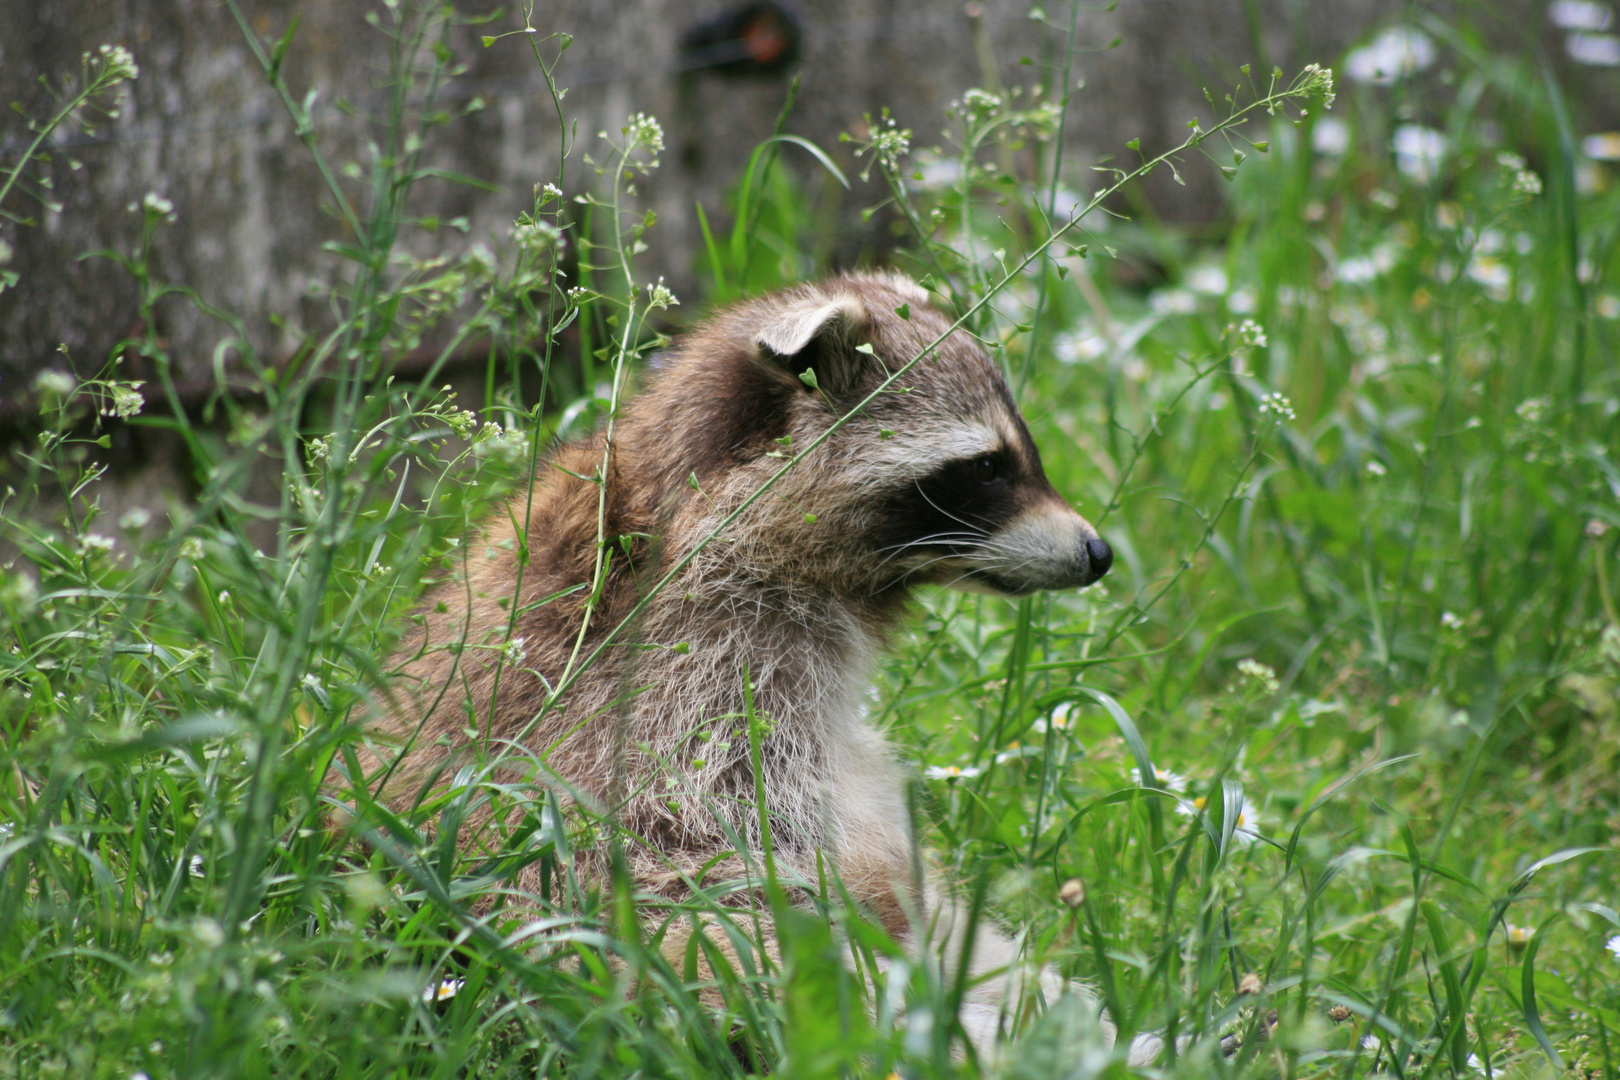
xmin=0 ymin=2 xmax=1620 ymax=1080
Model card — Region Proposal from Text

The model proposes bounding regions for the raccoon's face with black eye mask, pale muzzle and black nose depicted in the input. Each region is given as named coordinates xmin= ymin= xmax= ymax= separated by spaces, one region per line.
xmin=757 ymin=277 xmax=1113 ymax=596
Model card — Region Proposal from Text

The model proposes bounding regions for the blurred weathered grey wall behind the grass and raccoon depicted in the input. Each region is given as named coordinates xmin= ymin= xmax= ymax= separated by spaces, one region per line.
xmin=0 ymin=0 xmax=1539 ymax=424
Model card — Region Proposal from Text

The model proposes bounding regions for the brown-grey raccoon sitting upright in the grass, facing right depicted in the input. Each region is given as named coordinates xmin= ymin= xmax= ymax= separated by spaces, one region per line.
xmin=372 ymin=274 xmax=1113 ymax=1044
